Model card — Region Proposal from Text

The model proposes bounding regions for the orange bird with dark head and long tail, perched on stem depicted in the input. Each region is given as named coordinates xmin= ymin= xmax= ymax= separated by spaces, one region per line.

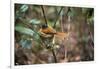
xmin=39 ymin=24 xmax=68 ymax=44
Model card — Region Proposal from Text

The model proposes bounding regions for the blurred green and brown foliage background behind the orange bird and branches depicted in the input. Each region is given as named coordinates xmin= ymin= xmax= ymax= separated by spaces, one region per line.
xmin=15 ymin=4 xmax=94 ymax=65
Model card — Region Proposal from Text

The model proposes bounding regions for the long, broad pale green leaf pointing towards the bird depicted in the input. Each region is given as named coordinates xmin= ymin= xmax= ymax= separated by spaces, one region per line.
xmin=15 ymin=26 xmax=35 ymax=36
